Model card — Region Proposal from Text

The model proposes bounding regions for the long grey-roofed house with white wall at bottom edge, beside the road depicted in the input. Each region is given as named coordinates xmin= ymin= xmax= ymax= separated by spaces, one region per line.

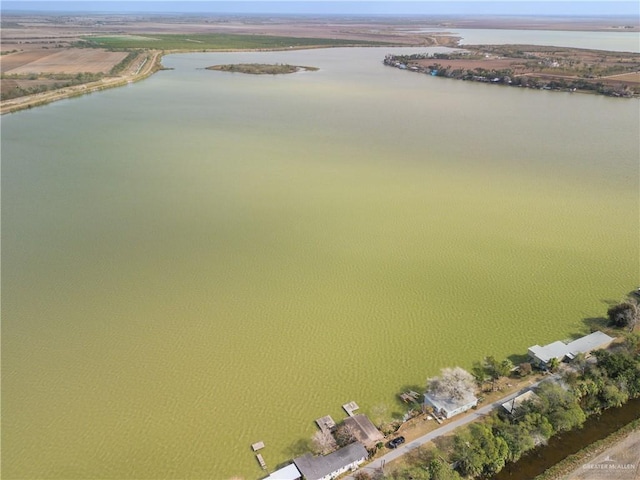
xmin=293 ymin=442 xmax=369 ymax=480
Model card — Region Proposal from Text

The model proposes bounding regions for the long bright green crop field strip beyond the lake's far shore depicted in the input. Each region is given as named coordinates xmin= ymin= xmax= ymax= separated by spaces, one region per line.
xmin=76 ymin=33 xmax=389 ymax=51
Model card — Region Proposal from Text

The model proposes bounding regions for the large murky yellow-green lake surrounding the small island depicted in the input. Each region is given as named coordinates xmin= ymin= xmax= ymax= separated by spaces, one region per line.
xmin=1 ymin=42 xmax=639 ymax=479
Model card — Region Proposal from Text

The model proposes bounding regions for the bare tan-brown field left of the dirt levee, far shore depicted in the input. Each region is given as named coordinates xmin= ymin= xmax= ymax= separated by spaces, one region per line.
xmin=3 ymin=49 xmax=127 ymax=74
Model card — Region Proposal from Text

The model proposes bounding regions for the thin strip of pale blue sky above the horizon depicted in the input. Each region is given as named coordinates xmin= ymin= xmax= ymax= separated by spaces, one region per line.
xmin=0 ymin=0 xmax=640 ymax=18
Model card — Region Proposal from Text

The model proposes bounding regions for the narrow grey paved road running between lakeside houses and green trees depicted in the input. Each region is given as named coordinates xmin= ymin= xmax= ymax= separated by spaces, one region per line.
xmin=344 ymin=375 xmax=557 ymax=480
